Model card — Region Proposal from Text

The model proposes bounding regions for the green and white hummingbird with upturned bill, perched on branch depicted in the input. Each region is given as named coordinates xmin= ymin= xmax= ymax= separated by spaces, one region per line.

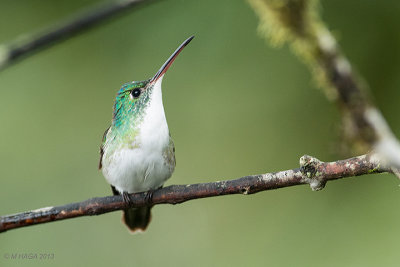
xmin=99 ymin=36 xmax=194 ymax=233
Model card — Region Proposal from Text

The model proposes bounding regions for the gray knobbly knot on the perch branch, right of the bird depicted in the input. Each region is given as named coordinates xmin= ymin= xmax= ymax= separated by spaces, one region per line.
xmin=300 ymin=155 xmax=326 ymax=191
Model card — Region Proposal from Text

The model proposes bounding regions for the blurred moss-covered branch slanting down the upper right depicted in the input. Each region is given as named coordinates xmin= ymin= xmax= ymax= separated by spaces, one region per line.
xmin=248 ymin=0 xmax=400 ymax=169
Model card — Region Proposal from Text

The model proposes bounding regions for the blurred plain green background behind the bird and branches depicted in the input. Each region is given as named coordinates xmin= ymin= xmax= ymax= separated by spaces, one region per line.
xmin=0 ymin=0 xmax=400 ymax=267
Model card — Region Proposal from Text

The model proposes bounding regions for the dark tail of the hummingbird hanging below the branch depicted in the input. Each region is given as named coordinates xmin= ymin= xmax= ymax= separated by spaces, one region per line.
xmin=122 ymin=207 xmax=151 ymax=233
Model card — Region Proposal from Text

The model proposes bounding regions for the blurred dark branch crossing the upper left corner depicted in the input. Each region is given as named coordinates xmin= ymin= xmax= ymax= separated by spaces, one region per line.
xmin=0 ymin=0 xmax=149 ymax=70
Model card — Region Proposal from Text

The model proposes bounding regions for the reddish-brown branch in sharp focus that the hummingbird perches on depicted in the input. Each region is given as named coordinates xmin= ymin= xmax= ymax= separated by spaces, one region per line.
xmin=0 ymin=154 xmax=391 ymax=232
